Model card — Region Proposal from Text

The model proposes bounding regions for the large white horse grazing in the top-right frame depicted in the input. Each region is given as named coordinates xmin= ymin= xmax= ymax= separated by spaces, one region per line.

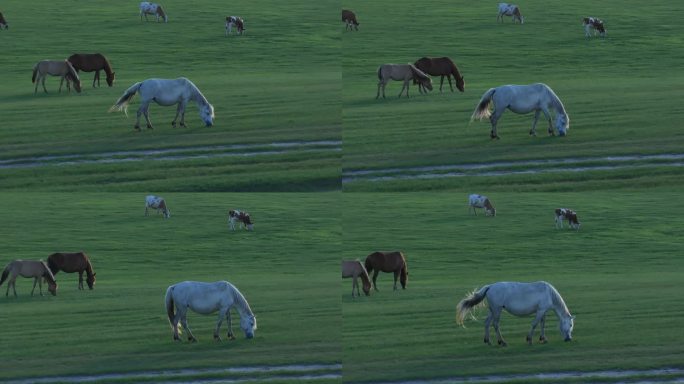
xmin=470 ymin=83 xmax=570 ymax=139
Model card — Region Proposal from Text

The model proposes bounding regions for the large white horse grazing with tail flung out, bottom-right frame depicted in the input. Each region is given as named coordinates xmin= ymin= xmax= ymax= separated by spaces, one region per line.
xmin=456 ymin=281 xmax=575 ymax=347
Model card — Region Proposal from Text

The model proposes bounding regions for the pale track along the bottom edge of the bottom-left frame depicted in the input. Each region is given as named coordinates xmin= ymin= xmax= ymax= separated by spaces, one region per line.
xmin=7 ymin=364 xmax=342 ymax=384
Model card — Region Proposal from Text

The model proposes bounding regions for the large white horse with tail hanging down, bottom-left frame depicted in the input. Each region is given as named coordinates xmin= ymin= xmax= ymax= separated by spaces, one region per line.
xmin=164 ymin=281 xmax=257 ymax=342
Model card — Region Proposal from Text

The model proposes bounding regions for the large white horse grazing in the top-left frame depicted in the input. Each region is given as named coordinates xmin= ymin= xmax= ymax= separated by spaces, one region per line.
xmin=109 ymin=77 xmax=214 ymax=130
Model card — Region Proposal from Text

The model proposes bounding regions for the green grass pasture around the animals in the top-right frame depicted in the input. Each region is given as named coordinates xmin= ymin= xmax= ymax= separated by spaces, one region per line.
xmin=340 ymin=0 xmax=684 ymax=192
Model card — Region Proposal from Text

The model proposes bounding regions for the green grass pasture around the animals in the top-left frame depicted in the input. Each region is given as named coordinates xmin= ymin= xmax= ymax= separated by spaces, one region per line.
xmin=0 ymin=0 xmax=341 ymax=191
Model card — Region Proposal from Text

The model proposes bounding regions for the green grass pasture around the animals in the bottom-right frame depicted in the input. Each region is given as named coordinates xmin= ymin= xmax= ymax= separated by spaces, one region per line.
xmin=339 ymin=194 xmax=684 ymax=383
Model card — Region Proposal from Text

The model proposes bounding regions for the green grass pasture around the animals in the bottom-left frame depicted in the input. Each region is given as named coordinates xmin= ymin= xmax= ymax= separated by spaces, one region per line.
xmin=0 ymin=192 xmax=341 ymax=382
